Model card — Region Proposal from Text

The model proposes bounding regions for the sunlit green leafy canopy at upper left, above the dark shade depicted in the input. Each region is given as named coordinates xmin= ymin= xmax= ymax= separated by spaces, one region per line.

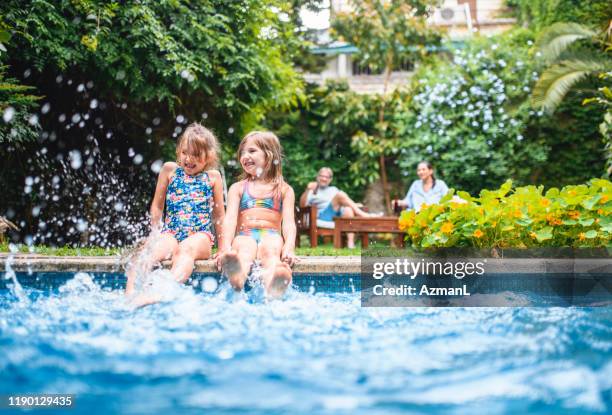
xmin=0 ymin=0 xmax=301 ymax=150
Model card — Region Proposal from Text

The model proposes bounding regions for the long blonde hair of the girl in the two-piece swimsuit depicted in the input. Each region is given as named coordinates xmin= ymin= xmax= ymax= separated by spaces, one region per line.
xmin=237 ymin=131 xmax=284 ymax=191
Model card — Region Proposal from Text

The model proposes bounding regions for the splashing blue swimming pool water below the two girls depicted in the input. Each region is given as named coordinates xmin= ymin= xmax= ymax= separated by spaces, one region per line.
xmin=0 ymin=273 xmax=612 ymax=414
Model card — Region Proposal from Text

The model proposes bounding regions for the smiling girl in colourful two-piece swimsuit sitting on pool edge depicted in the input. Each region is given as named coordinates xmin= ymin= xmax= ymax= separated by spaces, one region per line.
xmin=217 ymin=131 xmax=297 ymax=297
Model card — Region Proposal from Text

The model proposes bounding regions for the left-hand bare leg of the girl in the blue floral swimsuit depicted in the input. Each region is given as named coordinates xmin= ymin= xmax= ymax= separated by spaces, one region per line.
xmin=125 ymin=233 xmax=178 ymax=295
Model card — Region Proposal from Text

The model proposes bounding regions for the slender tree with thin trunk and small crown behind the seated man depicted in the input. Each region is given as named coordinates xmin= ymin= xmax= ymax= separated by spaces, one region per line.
xmin=332 ymin=0 xmax=440 ymax=211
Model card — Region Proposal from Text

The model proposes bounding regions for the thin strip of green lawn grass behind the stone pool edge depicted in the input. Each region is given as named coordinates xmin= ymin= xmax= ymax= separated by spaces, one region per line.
xmin=0 ymin=243 xmax=361 ymax=256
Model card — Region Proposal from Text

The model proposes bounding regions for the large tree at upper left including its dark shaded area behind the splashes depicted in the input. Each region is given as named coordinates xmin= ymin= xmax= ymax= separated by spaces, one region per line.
xmin=0 ymin=0 xmax=302 ymax=246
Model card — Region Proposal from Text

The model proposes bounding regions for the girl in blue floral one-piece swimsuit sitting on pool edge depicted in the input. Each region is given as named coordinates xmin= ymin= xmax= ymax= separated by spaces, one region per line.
xmin=126 ymin=123 xmax=225 ymax=302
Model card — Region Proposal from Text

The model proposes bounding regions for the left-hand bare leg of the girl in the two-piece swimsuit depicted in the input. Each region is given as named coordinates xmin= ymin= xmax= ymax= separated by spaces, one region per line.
xmin=221 ymin=235 xmax=257 ymax=291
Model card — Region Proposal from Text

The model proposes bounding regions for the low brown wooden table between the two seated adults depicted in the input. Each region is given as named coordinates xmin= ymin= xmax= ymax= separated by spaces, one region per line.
xmin=333 ymin=216 xmax=404 ymax=248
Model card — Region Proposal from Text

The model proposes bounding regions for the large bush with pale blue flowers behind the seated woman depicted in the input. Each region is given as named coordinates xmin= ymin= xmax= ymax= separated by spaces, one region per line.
xmin=398 ymin=29 xmax=604 ymax=192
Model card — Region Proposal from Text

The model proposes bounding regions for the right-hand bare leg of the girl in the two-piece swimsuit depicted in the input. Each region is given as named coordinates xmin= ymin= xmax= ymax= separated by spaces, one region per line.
xmin=257 ymin=235 xmax=292 ymax=298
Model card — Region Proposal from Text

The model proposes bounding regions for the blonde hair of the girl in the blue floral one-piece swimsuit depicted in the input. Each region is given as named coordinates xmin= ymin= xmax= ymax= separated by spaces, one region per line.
xmin=176 ymin=122 xmax=219 ymax=170
